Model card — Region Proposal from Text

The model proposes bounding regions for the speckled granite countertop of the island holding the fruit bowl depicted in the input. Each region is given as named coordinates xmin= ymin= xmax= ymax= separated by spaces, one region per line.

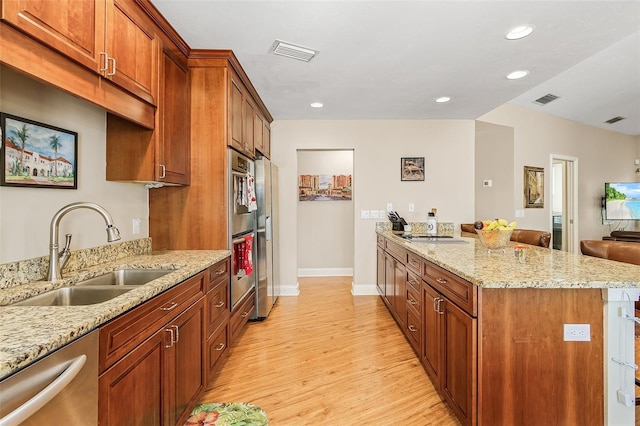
xmin=377 ymin=230 xmax=640 ymax=288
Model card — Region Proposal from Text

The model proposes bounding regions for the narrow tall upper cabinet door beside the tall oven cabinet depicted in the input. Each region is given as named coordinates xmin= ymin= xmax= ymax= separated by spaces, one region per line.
xmin=156 ymin=50 xmax=190 ymax=185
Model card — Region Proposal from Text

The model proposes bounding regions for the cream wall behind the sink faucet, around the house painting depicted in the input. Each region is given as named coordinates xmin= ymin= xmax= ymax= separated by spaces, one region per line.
xmin=0 ymin=67 xmax=149 ymax=263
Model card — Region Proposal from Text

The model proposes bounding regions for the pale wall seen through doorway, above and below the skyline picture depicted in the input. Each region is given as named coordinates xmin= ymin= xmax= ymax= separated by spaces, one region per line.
xmin=297 ymin=150 xmax=354 ymax=276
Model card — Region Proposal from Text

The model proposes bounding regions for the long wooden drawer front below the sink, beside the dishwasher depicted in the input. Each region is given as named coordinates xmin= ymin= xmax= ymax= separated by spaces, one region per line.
xmin=99 ymin=272 xmax=205 ymax=372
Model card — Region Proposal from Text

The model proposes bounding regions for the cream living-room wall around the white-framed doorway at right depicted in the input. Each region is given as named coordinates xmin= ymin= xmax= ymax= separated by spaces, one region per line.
xmin=479 ymin=104 xmax=640 ymax=240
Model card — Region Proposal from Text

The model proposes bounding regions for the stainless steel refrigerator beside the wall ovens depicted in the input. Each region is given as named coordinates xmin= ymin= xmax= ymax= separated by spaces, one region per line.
xmin=255 ymin=158 xmax=280 ymax=320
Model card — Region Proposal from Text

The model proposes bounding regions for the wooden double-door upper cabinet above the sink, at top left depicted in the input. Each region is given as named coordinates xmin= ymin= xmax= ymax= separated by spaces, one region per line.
xmin=0 ymin=0 xmax=159 ymax=105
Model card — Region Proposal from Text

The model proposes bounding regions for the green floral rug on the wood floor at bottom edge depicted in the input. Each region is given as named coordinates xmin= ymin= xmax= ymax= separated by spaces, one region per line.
xmin=185 ymin=402 xmax=269 ymax=426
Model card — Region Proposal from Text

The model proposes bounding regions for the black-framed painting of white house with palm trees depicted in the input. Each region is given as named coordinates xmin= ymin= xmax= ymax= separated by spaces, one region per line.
xmin=0 ymin=113 xmax=78 ymax=189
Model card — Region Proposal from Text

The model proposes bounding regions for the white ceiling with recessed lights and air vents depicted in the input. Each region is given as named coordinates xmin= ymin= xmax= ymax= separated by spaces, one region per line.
xmin=152 ymin=0 xmax=640 ymax=135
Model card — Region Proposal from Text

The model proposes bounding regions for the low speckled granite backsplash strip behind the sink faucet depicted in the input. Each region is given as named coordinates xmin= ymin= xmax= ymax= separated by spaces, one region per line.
xmin=0 ymin=238 xmax=151 ymax=289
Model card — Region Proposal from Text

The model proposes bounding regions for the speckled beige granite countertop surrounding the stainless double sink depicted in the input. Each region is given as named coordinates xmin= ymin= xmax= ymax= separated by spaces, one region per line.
xmin=0 ymin=250 xmax=231 ymax=379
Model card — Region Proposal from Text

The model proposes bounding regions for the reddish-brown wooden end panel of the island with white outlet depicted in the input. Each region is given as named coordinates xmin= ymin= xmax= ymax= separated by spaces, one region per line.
xmin=478 ymin=288 xmax=604 ymax=425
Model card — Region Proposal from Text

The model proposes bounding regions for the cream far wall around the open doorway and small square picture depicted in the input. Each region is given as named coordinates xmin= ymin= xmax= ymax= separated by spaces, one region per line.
xmin=272 ymin=120 xmax=475 ymax=294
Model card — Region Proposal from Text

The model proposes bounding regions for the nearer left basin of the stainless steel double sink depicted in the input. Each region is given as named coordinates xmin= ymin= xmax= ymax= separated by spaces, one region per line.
xmin=12 ymin=286 xmax=135 ymax=306
